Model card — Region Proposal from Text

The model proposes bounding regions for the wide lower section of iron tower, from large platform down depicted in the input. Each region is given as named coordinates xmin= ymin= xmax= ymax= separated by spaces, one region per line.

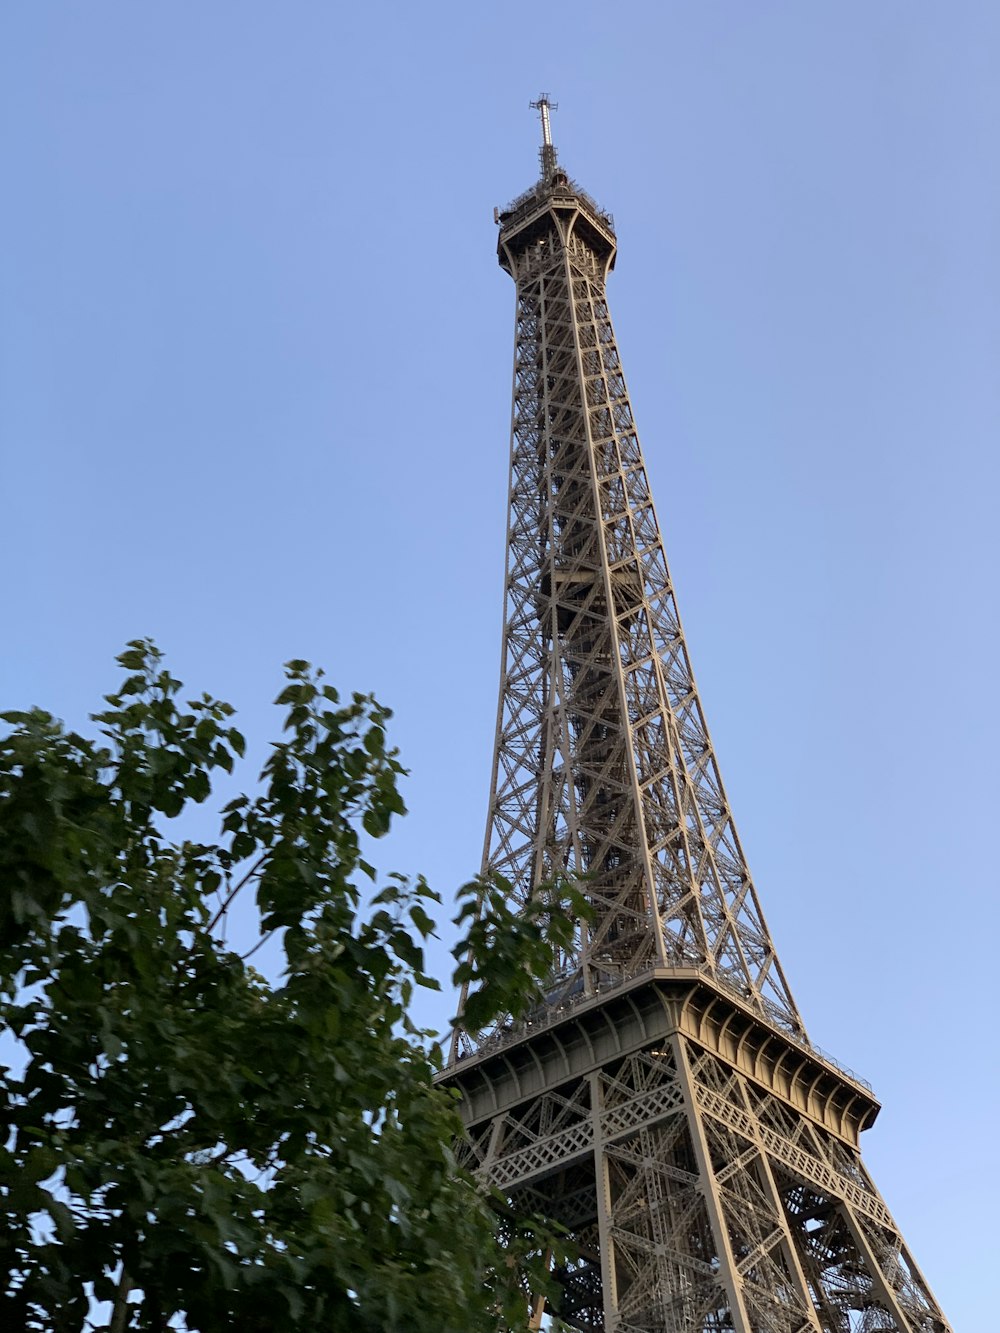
xmin=441 ymin=969 xmax=948 ymax=1333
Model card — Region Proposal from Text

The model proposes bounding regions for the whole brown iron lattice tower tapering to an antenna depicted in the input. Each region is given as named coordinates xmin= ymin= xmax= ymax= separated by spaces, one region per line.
xmin=443 ymin=97 xmax=948 ymax=1333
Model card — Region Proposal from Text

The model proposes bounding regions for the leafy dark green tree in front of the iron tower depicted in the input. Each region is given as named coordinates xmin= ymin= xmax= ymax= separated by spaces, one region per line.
xmin=0 ymin=641 xmax=571 ymax=1333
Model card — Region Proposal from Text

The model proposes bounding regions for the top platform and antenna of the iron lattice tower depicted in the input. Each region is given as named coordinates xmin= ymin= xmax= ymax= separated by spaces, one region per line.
xmin=493 ymin=93 xmax=617 ymax=279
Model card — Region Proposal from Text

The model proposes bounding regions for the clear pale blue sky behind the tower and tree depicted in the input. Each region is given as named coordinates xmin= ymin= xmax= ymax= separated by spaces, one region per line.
xmin=0 ymin=0 xmax=1000 ymax=1333
